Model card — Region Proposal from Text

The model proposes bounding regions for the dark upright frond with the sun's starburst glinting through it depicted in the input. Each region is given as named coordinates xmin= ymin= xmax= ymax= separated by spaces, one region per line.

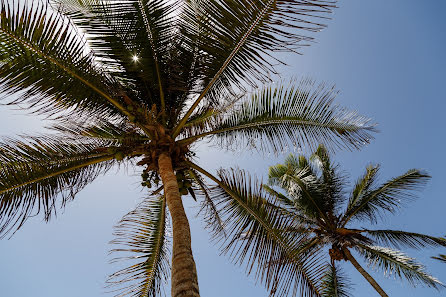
xmin=53 ymin=0 xmax=186 ymax=111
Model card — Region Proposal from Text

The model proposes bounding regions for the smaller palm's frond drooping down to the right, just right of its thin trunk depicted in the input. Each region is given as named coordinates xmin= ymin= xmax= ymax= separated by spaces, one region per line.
xmin=356 ymin=244 xmax=444 ymax=289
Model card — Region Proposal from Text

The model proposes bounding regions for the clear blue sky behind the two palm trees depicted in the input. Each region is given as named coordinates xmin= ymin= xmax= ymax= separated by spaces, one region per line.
xmin=0 ymin=0 xmax=446 ymax=297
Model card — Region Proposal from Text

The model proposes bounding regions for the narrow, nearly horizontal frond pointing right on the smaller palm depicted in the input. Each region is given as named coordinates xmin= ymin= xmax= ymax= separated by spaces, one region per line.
xmin=364 ymin=230 xmax=446 ymax=249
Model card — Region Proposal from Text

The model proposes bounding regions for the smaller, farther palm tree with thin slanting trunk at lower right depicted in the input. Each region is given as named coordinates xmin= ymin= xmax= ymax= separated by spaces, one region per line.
xmin=225 ymin=145 xmax=446 ymax=296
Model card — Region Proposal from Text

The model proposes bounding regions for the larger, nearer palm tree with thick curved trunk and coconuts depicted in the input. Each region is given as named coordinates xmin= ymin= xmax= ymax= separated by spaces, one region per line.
xmin=0 ymin=0 xmax=373 ymax=297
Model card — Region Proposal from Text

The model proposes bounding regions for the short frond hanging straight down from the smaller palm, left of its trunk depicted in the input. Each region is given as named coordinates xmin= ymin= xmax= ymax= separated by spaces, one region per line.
xmin=322 ymin=263 xmax=352 ymax=297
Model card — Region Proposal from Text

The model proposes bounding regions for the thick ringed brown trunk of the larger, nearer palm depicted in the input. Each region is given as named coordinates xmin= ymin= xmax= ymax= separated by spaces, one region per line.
xmin=158 ymin=153 xmax=200 ymax=297
